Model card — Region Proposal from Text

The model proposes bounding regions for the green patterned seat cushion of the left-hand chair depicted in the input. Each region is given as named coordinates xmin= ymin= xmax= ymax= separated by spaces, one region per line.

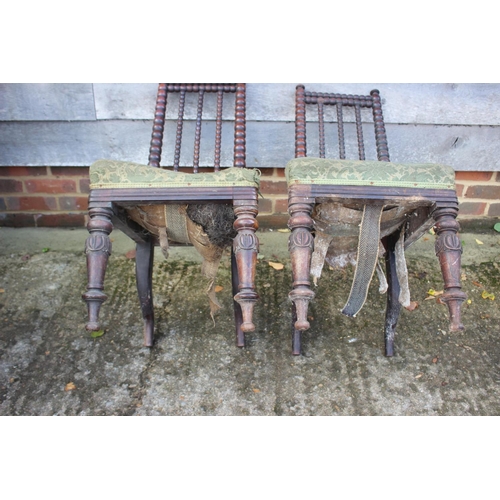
xmin=89 ymin=160 xmax=260 ymax=189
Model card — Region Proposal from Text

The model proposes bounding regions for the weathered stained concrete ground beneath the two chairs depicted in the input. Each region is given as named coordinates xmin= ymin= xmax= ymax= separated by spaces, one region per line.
xmin=0 ymin=228 xmax=500 ymax=415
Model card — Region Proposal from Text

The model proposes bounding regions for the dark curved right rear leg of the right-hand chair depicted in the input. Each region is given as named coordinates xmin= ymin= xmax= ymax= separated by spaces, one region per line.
xmin=383 ymin=233 xmax=401 ymax=356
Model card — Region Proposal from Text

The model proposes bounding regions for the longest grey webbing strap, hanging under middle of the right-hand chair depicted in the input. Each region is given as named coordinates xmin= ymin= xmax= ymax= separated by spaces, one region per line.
xmin=342 ymin=205 xmax=384 ymax=318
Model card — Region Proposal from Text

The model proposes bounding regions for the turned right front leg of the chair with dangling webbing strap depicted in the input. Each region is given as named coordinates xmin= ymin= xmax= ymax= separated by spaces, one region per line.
xmin=433 ymin=207 xmax=467 ymax=332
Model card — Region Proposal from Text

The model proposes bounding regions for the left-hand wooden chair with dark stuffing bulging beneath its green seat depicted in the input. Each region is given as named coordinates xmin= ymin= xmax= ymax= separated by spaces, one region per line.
xmin=83 ymin=83 xmax=260 ymax=346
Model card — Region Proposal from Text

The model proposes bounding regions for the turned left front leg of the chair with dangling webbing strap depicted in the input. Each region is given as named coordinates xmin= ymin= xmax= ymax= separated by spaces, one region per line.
xmin=288 ymin=199 xmax=314 ymax=354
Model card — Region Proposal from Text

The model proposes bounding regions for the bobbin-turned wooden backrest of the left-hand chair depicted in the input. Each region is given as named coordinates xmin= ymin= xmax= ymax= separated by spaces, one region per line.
xmin=148 ymin=83 xmax=246 ymax=173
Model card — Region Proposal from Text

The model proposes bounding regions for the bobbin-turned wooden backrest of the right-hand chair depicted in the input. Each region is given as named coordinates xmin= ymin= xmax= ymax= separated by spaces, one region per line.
xmin=295 ymin=85 xmax=390 ymax=161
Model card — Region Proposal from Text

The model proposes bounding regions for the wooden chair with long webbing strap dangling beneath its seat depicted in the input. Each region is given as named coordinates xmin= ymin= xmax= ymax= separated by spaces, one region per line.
xmin=286 ymin=85 xmax=466 ymax=356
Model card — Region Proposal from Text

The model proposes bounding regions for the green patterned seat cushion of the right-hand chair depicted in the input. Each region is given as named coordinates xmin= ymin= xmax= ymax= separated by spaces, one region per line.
xmin=285 ymin=158 xmax=455 ymax=189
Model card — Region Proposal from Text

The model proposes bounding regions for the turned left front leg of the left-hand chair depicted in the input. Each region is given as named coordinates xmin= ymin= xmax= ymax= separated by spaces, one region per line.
xmin=82 ymin=208 xmax=113 ymax=331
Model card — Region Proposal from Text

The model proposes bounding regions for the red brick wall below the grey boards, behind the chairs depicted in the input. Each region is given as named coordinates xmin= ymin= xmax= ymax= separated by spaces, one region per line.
xmin=0 ymin=167 xmax=500 ymax=227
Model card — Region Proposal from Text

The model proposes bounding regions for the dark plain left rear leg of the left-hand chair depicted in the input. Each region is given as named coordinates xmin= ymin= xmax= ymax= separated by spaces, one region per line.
xmin=135 ymin=238 xmax=154 ymax=347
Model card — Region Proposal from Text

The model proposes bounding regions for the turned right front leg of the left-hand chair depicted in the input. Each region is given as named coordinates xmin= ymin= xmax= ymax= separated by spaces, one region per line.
xmin=233 ymin=200 xmax=259 ymax=336
